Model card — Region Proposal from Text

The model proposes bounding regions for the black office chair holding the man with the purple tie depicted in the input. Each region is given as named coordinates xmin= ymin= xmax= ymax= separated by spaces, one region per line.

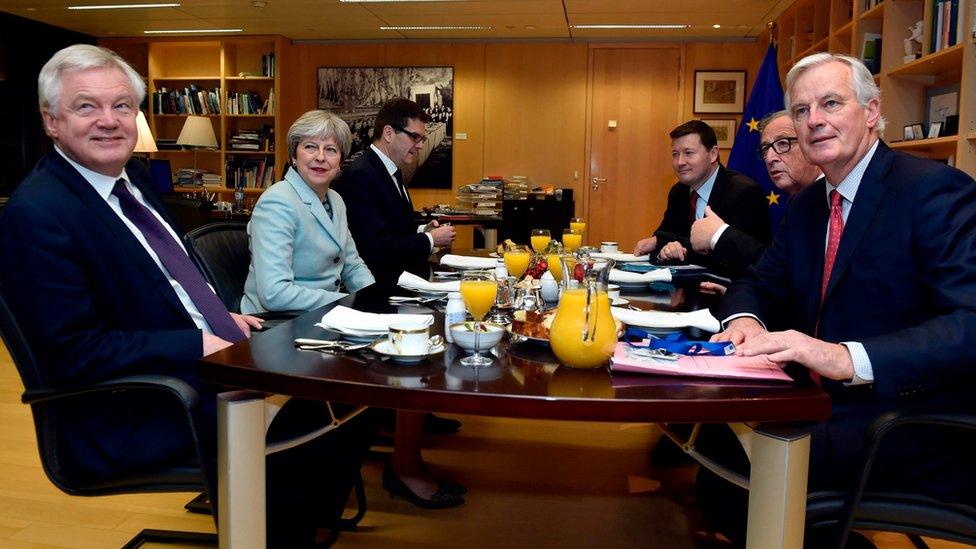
xmin=0 ymin=296 xmax=217 ymax=549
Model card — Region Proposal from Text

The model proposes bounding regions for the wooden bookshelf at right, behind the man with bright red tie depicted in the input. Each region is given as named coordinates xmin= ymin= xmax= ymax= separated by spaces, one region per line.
xmin=775 ymin=0 xmax=976 ymax=176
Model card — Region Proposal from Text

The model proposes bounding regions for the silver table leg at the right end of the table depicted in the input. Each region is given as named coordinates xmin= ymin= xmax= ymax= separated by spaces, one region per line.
xmin=746 ymin=427 xmax=810 ymax=549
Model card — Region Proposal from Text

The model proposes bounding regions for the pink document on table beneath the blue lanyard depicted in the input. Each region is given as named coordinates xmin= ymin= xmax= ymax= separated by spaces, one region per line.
xmin=610 ymin=342 xmax=793 ymax=382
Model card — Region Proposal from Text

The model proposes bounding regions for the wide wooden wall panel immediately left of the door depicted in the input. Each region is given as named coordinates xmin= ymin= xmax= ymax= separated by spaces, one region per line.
xmin=484 ymin=43 xmax=587 ymax=213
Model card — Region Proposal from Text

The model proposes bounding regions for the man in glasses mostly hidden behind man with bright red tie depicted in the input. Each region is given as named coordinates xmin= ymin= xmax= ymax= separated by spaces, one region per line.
xmin=690 ymin=110 xmax=823 ymax=286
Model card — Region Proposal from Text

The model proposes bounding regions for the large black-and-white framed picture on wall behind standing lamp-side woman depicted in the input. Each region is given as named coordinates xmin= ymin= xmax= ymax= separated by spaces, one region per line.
xmin=316 ymin=67 xmax=454 ymax=189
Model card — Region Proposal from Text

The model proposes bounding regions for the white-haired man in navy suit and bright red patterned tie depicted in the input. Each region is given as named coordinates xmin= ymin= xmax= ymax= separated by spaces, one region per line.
xmin=713 ymin=53 xmax=976 ymax=544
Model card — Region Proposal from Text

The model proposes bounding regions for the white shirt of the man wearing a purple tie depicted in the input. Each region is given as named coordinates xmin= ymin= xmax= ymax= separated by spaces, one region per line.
xmin=54 ymin=146 xmax=213 ymax=333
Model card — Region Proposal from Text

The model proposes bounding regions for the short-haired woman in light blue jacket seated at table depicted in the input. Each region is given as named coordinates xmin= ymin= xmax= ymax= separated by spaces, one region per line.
xmin=241 ymin=110 xmax=375 ymax=314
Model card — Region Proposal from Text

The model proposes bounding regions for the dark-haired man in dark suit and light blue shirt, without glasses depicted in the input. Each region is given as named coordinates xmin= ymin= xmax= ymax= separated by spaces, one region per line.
xmin=634 ymin=120 xmax=770 ymax=277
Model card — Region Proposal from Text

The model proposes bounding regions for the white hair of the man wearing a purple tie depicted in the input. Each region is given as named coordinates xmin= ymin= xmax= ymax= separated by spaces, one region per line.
xmin=37 ymin=44 xmax=146 ymax=116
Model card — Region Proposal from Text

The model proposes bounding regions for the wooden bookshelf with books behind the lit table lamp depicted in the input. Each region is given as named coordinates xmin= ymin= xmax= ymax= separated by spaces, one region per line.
xmin=100 ymin=36 xmax=287 ymax=200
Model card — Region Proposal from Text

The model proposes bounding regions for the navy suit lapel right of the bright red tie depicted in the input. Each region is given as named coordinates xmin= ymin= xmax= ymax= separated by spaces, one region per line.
xmin=821 ymin=142 xmax=892 ymax=300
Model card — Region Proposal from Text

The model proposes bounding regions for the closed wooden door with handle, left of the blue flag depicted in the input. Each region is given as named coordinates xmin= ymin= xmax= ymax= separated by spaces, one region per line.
xmin=584 ymin=47 xmax=683 ymax=252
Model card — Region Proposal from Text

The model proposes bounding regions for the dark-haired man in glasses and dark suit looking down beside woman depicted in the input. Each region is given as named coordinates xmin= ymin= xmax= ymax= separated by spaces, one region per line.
xmin=333 ymin=98 xmax=455 ymax=300
